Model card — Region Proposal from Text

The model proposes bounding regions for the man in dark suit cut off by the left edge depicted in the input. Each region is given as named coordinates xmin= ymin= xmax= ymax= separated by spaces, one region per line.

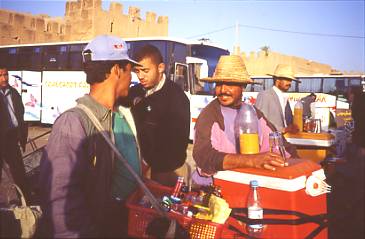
xmin=0 ymin=66 xmax=30 ymax=200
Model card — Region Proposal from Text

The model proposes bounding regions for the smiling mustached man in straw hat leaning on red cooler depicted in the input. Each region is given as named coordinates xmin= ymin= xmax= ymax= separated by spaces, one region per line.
xmin=193 ymin=55 xmax=294 ymax=176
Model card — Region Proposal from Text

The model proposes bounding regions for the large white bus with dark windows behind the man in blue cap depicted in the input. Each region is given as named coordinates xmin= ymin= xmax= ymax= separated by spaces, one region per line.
xmin=0 ymin=37 xmax=229 ymax=139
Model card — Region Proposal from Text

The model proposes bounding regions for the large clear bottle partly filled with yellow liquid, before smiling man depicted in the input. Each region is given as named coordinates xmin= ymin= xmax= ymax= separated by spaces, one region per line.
xmin=235 ymin=103 xmax=260 ymax=154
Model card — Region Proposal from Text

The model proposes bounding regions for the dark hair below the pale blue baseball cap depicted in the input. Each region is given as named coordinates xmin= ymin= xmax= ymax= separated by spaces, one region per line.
xmin=83 ymin=60 xmax=131 ymax=85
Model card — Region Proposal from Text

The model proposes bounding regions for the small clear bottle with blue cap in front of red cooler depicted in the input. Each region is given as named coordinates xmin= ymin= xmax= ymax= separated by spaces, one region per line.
xmin=247 ymin=180 xmax=264 ymax=235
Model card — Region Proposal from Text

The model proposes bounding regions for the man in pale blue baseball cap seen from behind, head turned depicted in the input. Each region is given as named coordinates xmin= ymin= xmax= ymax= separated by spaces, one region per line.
xmin=40 ymin=35 xmax=141 ymax=238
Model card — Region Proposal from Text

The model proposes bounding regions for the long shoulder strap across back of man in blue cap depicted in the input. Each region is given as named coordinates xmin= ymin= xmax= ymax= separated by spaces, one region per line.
xmin=76 ymin=104 xmax=166 ymax=216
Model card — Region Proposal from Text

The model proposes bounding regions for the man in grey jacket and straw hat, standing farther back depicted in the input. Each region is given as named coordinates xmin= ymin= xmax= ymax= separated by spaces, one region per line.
xmin=255 ymin=64 xmax=300 ymax=134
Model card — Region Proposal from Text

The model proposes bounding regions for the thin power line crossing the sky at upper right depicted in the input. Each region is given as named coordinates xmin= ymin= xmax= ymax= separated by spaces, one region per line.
xmin=188 ymin=24 xmax=365 ymax=39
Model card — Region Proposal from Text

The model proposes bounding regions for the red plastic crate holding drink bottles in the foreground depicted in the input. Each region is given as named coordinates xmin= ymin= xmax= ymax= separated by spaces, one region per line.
xmin=127 ymin=184 xmax=224 ymax=239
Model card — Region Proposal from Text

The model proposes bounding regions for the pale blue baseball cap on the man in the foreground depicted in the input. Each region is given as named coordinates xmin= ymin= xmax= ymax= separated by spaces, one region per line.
xmin=82 ymin=35 xmax=140 ymax=65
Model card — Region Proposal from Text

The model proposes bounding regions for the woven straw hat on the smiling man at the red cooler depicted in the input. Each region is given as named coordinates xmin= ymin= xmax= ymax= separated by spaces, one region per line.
xmin=200 ymin=55 xmax=254 ymax=84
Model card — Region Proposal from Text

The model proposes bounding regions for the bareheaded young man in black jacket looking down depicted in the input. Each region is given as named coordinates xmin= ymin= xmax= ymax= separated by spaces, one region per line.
xmin=130 ymin=45 xmax=190 ymax=186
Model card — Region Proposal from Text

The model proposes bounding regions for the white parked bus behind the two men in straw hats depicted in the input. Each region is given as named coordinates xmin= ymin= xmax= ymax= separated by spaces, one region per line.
xmin=198 ymin=75 xmax=365 ymax=131
